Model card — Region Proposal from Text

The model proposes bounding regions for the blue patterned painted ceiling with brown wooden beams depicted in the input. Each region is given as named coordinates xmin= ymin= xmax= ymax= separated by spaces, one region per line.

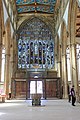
xmin=16 ymin=0 xmax=56 ymax=13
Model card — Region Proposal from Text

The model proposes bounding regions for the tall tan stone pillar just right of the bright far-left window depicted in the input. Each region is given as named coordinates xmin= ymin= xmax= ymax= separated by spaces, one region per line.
xmin=5 ymin=21 xmax=11 ymax=99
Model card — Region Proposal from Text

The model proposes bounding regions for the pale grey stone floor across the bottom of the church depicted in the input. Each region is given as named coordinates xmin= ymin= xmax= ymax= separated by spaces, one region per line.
xmin=0 ymin=100 xmax=80 ymax=120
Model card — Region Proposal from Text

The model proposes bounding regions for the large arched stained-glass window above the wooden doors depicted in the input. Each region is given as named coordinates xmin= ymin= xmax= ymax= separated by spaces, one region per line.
xmin=18 ymin=18 xmax=54 ymax=69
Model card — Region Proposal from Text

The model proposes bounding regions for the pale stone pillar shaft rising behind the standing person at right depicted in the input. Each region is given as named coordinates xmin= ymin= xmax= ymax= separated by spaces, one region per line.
xmin=70 ymin=44 xmax=79 ymax=101
